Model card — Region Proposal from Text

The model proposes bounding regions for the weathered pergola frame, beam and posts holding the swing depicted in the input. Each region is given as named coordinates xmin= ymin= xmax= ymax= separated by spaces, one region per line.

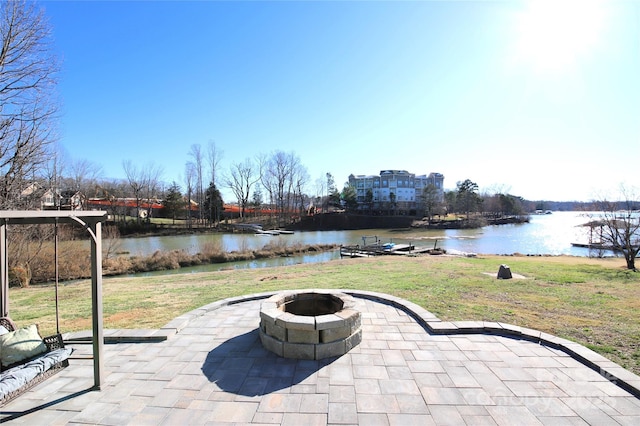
xmin=0 ymin=210 xmax=107 ymax=389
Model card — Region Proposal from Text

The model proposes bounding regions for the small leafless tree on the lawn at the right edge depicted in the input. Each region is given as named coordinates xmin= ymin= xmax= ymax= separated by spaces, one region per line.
xmin=589 ymin=187 xmax=640 ymax=271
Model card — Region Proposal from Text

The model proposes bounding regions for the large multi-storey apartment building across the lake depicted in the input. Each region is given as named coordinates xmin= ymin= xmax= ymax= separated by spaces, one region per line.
xmin=349 ymin=170 xmax=444 ymax=213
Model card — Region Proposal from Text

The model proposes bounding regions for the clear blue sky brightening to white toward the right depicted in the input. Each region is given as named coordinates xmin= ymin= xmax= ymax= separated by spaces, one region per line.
xmin=42 ymin=0 xmax=640 ymax=201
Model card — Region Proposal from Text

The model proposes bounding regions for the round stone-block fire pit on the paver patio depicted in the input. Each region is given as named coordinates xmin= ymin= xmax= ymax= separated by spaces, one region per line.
xmin=260 ymin=290 xmax=362 ymax=359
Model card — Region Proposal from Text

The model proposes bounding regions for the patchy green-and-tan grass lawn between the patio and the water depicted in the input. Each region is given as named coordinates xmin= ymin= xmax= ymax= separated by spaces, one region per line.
xmin=9 ymin=256 xmax=640 ymax=374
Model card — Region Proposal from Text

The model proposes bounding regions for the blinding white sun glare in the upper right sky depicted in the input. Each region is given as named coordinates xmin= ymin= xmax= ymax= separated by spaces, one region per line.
xmin=515 ymin=0 xmax=606 ymax=73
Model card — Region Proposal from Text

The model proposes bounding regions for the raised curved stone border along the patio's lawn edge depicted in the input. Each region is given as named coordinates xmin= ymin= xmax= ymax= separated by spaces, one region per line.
xmin=155 ymin=289 xmax=640 ymax=398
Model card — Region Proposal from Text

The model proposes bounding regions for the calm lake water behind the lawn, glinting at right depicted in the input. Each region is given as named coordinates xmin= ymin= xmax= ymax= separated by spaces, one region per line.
xmin=118 ymin=212 xmax=604 ymax=274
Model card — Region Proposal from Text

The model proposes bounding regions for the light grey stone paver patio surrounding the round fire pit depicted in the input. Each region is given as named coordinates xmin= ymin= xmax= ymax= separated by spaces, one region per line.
xmin=0 ymin=292 xmax=640 ymax=426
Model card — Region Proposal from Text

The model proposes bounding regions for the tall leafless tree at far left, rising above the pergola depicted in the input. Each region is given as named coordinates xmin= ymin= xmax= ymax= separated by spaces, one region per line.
xmin=0 ymin=0 xmax=58 ymax=208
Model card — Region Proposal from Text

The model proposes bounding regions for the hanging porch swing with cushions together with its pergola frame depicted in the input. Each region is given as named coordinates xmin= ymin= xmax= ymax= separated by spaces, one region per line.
xmin=0 ymin=210 xmax=106 ymax=405
